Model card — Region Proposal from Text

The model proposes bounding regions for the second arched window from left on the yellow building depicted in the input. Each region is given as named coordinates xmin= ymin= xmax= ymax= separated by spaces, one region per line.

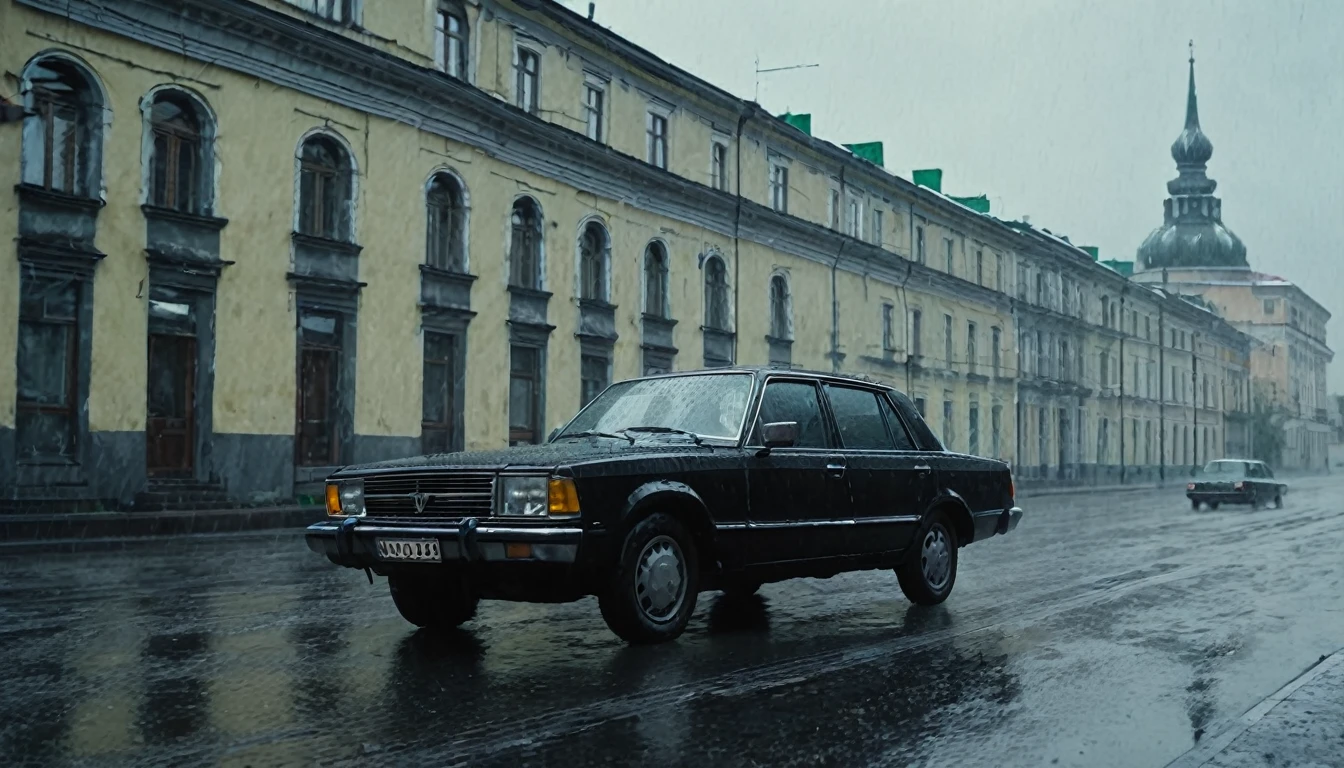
xmin=149 ymin=90 xmax=212 ymax=214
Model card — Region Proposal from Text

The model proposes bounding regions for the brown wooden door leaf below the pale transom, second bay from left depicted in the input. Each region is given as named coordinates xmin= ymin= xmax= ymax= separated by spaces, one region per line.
xmin=145 ymin=334 xmax=196 ymax=476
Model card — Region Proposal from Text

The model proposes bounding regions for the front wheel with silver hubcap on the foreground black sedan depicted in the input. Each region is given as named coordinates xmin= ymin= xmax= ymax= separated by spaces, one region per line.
xmin=598 ymin=512 xmax=700 ymax=646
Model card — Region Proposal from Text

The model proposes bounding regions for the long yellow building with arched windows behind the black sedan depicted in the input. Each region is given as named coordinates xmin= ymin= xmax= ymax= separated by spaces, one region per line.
xmin=0 ymin=0 xmax=1251 ymax=506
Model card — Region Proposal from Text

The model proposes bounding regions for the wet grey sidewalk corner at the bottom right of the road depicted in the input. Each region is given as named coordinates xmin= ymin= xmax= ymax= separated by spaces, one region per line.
xmin=1167 ymin=651 xmax=1344 ymax=768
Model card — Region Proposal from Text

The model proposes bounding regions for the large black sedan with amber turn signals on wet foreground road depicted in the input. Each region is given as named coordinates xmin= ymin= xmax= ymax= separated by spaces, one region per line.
xmin=306 ymin=369 xmax=1021 ymax=643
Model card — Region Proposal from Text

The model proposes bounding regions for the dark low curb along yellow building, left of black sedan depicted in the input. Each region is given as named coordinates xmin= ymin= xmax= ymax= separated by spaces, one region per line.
xmin=0 ymin=506 xmax=325 ymax=551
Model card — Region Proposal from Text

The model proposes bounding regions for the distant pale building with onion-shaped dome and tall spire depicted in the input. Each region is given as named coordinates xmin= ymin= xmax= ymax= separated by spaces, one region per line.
xmin=1133 ymin=58 xmax=1335 ymax=469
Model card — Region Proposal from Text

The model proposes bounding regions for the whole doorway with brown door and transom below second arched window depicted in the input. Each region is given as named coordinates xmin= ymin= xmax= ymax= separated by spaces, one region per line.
xmin=145 ymin=299 xmax=196 ymax=477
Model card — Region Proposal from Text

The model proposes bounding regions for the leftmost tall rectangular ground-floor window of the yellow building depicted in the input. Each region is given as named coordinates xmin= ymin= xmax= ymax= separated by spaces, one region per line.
xmin=15 ymin=277 xmax=79 ymax=463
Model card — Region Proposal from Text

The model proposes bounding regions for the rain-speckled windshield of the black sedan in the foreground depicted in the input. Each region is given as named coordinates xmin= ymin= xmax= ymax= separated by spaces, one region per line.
xmin=556 ymin=374 xmax=751 ymax=440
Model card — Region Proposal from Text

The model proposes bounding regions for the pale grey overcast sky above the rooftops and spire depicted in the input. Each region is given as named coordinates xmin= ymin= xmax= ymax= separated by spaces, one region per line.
xmin=566 ymin=0 xmax=1344 ymax=393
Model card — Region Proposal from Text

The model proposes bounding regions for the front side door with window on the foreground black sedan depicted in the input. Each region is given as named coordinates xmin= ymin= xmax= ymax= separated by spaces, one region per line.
xmin=745 ymin=377 xmax=848 ymax=565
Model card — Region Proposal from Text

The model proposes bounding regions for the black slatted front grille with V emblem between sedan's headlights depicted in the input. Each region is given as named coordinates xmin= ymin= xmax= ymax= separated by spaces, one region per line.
xmin=364 ymin=472 xmax=495 ymax=521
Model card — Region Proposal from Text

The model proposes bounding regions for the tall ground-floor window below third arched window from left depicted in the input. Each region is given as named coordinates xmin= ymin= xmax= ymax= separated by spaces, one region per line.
xmin=294 ymin=309 xmax=343 ymax=467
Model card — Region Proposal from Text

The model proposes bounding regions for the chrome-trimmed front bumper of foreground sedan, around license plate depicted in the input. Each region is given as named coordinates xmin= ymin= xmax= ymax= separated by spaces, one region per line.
xmin=304 ymin=518 xmax=583 ymax=568
